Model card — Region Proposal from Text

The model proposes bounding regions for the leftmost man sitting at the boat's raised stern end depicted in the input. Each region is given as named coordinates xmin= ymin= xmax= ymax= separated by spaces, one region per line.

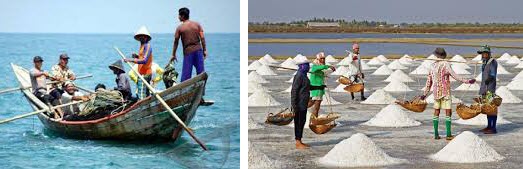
xmin=29 ymin=56 xmax=63 ymax=118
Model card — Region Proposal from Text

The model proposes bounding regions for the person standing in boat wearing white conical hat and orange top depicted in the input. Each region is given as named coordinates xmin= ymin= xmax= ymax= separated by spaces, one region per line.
xmin=124 ymin=26 xmax=153 ymax=99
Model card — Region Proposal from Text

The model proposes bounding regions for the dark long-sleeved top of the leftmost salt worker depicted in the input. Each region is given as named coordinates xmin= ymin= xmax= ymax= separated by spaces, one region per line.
xmin=291 ymin=71 xmax=310 ymax=111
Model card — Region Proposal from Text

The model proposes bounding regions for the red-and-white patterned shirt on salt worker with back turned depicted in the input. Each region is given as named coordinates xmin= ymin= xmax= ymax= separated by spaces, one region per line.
xmin=424 ymin=61 xmax=468 ymax=99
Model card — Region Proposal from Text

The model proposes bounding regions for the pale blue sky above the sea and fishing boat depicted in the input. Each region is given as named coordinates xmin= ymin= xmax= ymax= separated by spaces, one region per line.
xmin=0 ymin=0 xmax=240 ymax=33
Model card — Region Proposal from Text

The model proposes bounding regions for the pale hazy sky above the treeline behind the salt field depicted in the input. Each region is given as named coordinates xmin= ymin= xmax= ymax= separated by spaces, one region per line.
xmin=249 ymin=0 xmax=523 ymax=23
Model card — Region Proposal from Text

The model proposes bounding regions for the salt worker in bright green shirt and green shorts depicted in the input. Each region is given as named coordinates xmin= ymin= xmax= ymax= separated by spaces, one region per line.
xmin=309 ymin=52 xmax=336 ymax=117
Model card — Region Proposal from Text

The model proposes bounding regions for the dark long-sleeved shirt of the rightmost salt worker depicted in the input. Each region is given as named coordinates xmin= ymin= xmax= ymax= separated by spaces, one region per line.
xmin=479 ymin=58 xmax=498 ymax=95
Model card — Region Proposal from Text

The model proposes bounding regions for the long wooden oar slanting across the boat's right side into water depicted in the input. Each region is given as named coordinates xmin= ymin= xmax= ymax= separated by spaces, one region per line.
xmin=114 ymin=46 xmax=207 ymax=150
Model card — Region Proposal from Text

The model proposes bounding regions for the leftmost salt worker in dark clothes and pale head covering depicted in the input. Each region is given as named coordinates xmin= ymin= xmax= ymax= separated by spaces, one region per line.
xmin=291 ymin=59 xmax=310 ymax=149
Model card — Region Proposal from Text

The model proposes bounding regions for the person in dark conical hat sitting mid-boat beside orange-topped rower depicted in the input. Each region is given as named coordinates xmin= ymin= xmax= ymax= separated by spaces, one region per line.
xmin=109 ymin=60 xmax=133 ymax=101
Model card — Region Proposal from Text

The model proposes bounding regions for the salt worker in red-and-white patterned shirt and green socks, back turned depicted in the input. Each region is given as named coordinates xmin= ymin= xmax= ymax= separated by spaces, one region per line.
xmin=421 ymin=48 xmax=476 ymax=140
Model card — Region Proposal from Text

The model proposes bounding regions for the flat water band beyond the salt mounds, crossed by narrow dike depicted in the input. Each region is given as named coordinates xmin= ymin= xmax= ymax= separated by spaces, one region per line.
xmin=249 ymin=33 xmax=523 ymax=56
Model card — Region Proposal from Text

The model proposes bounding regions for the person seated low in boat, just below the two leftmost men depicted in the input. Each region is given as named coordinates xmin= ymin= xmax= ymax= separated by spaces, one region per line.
xmin=61 ymin=81 xmax=90 ymax=120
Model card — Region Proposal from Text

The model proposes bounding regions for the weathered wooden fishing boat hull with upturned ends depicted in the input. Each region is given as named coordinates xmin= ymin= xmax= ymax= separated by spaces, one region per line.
xmin=11 ymin=63 xmax=208 ymax=141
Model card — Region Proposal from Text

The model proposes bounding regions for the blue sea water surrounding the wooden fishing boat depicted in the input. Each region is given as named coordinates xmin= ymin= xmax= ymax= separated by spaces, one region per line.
xmin=0 ymin=33 xmax=240 ymax=168
